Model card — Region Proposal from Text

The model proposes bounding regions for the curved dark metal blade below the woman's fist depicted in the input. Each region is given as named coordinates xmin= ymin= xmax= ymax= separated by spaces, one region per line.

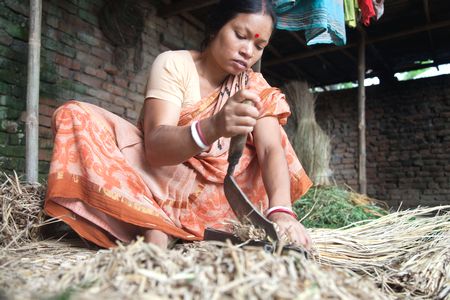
xmin=224 ymin=175 xmax=279 ymax=241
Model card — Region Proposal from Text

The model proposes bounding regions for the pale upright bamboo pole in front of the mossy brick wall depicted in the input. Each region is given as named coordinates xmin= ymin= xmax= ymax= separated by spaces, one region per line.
xmin=25 ymin=0 xmax=42 ymax=183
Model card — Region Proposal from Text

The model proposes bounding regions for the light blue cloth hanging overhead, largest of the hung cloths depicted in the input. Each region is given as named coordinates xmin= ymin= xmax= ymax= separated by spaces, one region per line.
xmin=274 ymin=0 xmax=346 ymax=46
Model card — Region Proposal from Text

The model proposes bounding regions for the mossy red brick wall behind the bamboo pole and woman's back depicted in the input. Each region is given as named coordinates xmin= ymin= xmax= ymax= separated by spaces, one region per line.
xmin=0 ymin=0 xmax=202 ymax=178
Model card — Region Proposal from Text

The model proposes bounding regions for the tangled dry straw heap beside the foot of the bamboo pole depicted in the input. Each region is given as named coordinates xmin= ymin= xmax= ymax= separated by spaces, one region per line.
xmin=0 ymin=173 xmax=45 ymax=248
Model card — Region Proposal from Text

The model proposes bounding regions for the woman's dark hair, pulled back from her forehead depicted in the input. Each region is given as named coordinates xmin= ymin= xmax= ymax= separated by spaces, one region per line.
xmin=201 ymin=0 xmax=277 ymax=49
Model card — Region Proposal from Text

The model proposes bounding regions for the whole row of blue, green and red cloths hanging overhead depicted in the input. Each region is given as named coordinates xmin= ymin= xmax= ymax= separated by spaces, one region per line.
xmin=274 ymin=0 xmax=384 ymax=46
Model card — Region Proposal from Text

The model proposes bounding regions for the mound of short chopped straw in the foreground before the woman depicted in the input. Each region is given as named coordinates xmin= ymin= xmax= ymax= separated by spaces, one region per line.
xmin=0 ymin=240 xmax=389 ymax=299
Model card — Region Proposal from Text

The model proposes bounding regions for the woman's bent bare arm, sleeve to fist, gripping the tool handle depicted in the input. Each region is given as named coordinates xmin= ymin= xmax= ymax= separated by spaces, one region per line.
xmin=143 ymin=90 xmax=260 ymax=166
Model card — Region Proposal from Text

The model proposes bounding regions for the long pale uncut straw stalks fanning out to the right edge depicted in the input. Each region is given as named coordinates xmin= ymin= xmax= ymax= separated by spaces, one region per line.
xmin=313 ymin=206 xmax=450 ymax=299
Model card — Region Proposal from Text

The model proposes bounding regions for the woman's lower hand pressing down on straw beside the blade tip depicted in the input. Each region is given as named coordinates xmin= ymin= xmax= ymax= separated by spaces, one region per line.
xmin=269 ymin=212 xmax=311 ymax=250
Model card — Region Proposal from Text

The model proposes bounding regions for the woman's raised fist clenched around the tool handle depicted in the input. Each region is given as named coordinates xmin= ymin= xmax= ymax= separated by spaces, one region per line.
xmin=213 ymin=90 xmax=261 ymax=137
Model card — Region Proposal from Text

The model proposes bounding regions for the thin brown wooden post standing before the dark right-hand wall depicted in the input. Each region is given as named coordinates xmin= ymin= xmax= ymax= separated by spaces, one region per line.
xmin=358 ymin=29 xmax=367 ymax=194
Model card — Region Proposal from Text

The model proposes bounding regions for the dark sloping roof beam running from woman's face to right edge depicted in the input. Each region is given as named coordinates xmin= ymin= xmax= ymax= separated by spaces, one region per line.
xmin=264 ymin=20 xmax=450 ymax=66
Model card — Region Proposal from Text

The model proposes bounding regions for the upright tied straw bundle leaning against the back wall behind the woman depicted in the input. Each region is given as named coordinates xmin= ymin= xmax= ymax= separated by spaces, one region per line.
xmin=283 ymin=81 xmax=331 ymax=185
